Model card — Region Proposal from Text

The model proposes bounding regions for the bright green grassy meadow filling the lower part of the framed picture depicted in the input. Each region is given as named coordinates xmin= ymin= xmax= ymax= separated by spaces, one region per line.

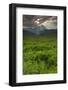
xmin=23 ymin=35 xmax=57 ymax=75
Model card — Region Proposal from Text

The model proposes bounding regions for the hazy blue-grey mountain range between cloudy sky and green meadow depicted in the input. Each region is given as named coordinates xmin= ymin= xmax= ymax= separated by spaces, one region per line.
xmin=23 ymin=26 xmax=57 ymax=35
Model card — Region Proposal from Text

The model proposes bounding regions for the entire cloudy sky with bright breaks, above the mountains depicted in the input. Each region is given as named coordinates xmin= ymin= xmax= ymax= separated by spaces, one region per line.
xmin=23 ymin=15 xmax=57 ymax=29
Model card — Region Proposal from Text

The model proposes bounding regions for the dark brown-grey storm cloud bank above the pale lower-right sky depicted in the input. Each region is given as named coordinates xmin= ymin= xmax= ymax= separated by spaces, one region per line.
xmin=23 ymin=15 xmax=57 ymax=28
